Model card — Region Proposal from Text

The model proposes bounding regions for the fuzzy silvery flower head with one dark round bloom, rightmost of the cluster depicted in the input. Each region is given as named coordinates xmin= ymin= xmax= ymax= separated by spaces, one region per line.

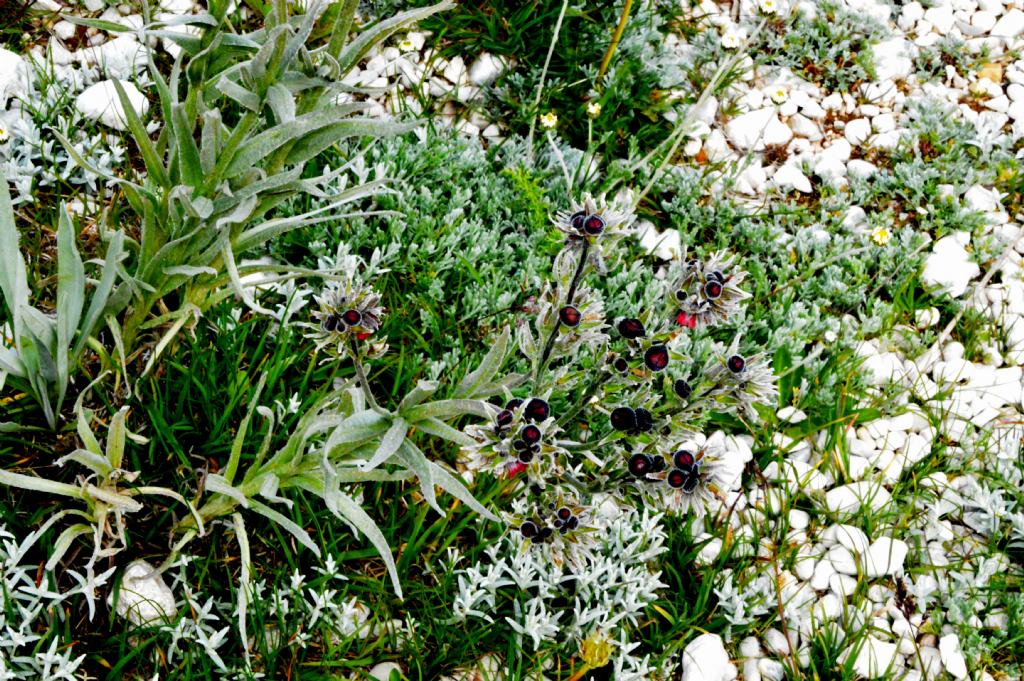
xmin=702 ymin=336 xmax=778 ymax=419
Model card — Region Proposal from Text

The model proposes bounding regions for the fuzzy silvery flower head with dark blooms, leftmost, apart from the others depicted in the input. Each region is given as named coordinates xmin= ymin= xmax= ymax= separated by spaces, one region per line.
xmin=304 ymin=251 xmax=387 ymax=358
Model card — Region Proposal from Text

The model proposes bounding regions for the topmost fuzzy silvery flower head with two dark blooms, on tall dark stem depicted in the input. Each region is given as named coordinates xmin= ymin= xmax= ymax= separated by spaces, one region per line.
xmin=554 ymin=190 xmax=636 ymax=274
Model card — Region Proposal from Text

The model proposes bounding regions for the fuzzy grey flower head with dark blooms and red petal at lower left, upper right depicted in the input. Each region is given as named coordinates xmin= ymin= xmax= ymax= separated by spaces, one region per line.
xmin=668 ymin=252 xmax=751 ymax=329
